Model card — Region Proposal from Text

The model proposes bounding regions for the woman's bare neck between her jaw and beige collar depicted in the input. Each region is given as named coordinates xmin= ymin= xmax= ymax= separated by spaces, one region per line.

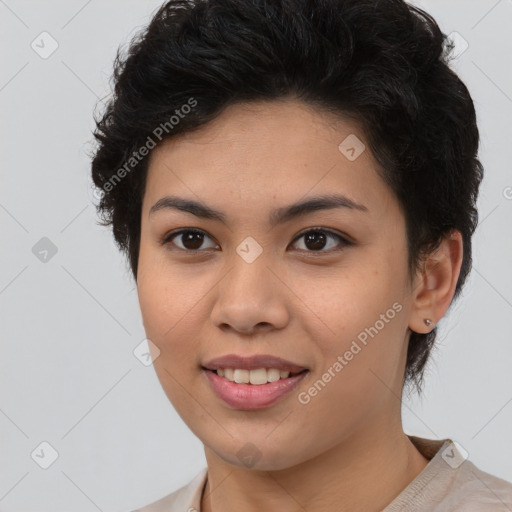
xmin=201 ymin=424 xmax=428 ymax=512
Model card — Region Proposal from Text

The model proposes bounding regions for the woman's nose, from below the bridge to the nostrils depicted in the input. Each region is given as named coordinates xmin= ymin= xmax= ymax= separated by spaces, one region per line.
xmin=211 ymin=255 xmax=290 ymax=334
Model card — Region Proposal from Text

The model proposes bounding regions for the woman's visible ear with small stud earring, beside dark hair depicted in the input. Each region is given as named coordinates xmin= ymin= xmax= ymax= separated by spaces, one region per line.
xmin=409 ymin=230 xmax=463 ymax=333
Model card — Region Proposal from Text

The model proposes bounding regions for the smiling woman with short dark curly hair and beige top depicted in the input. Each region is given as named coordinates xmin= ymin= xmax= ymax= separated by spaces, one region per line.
xmin=92 ymin=0 xmax=512 ymax=512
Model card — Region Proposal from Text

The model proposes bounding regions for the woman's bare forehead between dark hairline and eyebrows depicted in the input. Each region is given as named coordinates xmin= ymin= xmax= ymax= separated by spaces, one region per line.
xmin=144 ymin=101 xmax=396 ymax=221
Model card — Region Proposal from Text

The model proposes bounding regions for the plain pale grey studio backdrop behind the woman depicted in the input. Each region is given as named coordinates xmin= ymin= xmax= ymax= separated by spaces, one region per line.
xmin=0 ymin=0 xmax=512 ymax=512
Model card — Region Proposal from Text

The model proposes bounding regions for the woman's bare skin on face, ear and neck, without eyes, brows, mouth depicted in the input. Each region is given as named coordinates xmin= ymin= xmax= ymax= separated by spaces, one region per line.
xmin=137 ymin=99 xmax=462 ymax=512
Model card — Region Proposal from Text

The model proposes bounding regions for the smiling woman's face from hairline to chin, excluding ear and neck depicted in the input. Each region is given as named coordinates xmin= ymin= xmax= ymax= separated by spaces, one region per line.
xmin=137 ymin=100 xmax=411 ymax=470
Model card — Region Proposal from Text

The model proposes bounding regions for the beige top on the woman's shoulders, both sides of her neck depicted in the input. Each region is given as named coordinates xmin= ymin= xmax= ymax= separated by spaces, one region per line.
xmin=133 ymin=436 xmax=512 ymax=512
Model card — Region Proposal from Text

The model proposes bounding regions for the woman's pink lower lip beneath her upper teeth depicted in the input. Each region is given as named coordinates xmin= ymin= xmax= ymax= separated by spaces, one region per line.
xmin=203 ymin=369 xmax=308 ymax=410
